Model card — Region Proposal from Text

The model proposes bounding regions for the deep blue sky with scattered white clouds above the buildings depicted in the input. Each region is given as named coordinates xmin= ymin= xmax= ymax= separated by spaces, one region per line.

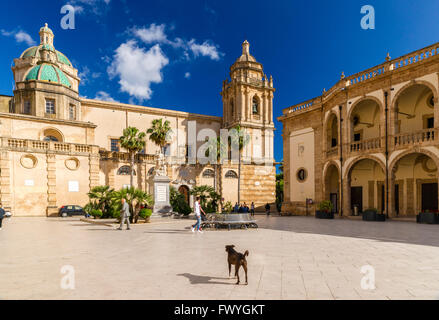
xmin=0 ymin=0 xmax=439 ymax=161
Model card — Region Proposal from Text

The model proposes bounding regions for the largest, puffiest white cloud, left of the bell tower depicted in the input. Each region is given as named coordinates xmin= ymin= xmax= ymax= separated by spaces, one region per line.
xmin=107 ymin=40 xmax=169 ymax=101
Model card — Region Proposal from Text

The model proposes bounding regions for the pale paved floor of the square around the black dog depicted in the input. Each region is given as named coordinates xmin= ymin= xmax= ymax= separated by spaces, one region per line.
xmin=0 ymin=216 xmax=439 ymax=300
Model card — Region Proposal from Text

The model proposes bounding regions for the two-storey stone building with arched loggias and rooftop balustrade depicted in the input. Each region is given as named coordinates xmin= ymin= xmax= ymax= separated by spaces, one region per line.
xmin=279 ymin=44 xmax=439 ymax=217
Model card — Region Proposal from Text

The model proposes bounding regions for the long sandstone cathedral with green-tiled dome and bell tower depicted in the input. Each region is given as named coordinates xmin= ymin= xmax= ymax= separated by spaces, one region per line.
xmin=0 ymin=24 xmax=275 ymax=216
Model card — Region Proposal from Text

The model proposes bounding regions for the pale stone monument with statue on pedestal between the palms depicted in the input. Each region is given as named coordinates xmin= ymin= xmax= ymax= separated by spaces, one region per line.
xmin=153 ymin=154 xmax=172 ymax=216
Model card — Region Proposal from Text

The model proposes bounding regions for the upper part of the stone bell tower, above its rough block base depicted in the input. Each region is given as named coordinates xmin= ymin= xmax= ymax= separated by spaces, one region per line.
xmin=221 ymin=40 xmax=275 ymax=162
